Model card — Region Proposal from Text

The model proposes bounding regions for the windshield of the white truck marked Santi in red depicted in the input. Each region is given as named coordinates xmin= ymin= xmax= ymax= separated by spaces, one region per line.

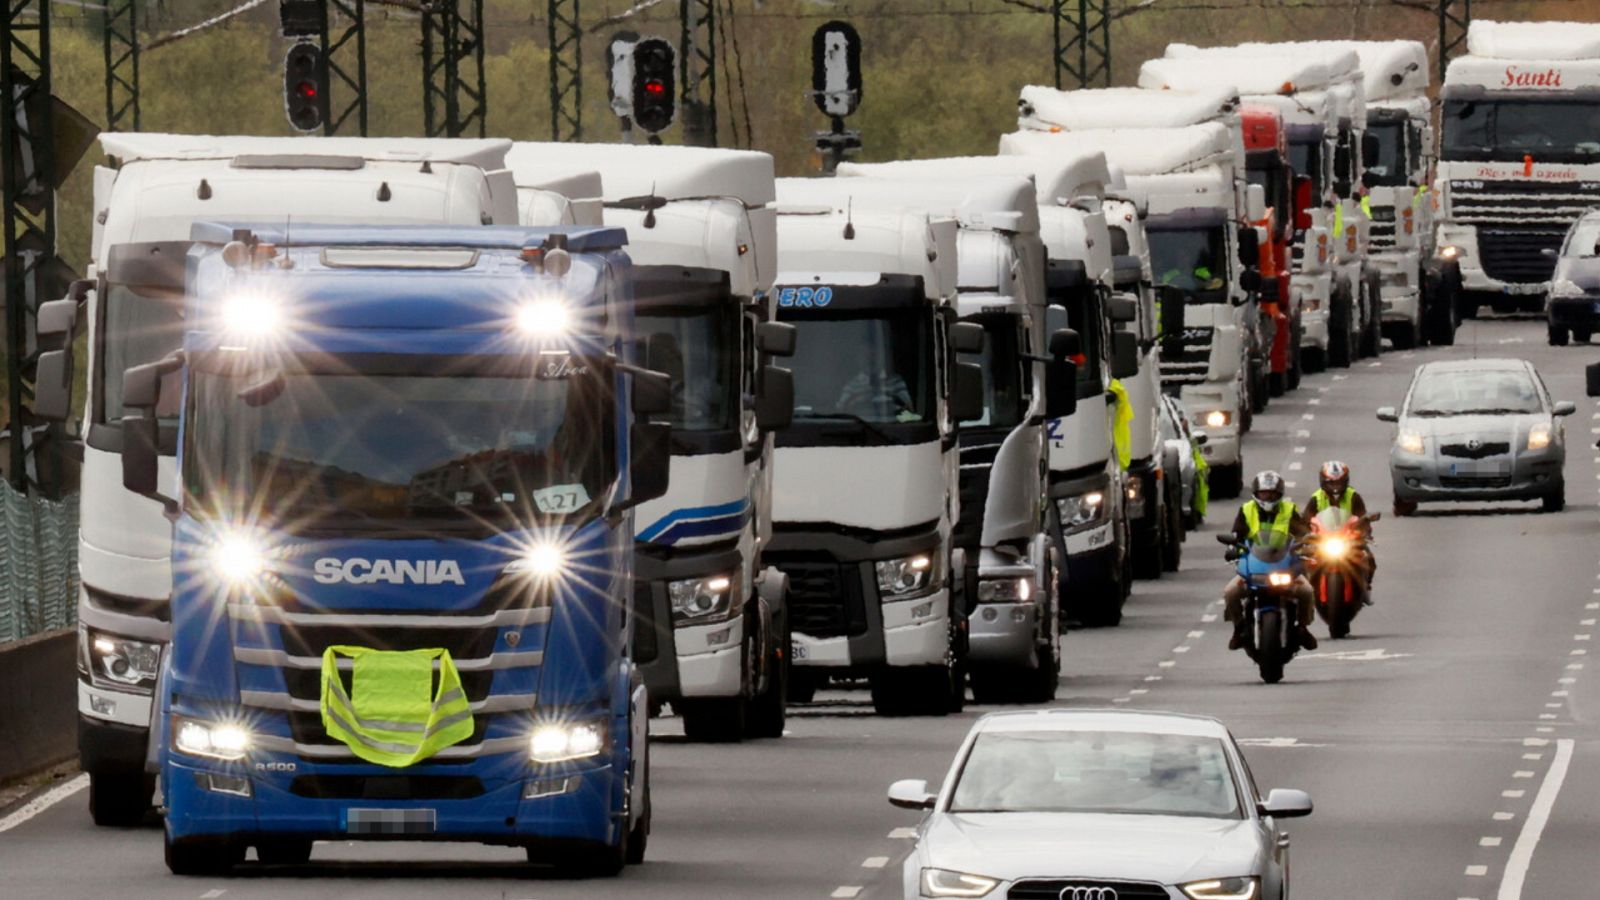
xmin=1443 ymin=98 xmax=1600 ymax=162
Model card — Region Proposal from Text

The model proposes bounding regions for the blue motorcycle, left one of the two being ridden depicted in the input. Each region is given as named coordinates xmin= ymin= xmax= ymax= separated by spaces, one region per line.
xmin=1216 ymin=535 xmax=1306 ymax=684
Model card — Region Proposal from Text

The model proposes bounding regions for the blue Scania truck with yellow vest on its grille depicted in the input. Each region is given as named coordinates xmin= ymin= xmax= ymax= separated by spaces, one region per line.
xmin=104 ymin=224 xmax=670 ymax=874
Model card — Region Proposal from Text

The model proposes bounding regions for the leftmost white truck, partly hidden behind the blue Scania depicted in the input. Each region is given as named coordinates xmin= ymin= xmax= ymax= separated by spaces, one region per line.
xmin=78 ymin=133 xmax=517 ymax=825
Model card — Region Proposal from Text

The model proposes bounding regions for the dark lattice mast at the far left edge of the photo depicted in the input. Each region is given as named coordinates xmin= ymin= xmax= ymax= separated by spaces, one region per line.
xmin=0 ymin=0 xmax=56 ymax=493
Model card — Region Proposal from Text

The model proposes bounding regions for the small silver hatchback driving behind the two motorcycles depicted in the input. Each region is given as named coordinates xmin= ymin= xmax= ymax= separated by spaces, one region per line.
xmin=1378 ymin=359 xmax=1578 ymax=516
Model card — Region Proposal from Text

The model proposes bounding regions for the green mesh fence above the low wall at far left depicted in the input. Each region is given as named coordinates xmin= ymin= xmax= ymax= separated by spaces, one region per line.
xmin=0 ymin=480 xmax=78 ymax=644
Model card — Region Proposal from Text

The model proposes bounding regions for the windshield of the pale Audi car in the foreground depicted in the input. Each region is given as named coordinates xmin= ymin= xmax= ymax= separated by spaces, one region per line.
xmin=949 ymin=732 xmax=1240 ymax=818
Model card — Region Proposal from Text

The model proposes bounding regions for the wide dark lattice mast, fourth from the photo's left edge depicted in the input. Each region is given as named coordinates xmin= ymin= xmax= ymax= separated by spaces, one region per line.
xmin=422 ymin=0 xmax=488 ymax=138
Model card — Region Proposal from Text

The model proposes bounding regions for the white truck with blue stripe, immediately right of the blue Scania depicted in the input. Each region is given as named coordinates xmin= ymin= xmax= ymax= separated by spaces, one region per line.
xmin=507 ymin=143 xmax=794 ymax=741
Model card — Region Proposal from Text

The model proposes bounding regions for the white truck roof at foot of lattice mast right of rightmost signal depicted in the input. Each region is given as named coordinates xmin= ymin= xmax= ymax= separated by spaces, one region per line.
xmin=1018 ymin=85 xmax=1238 ymax=131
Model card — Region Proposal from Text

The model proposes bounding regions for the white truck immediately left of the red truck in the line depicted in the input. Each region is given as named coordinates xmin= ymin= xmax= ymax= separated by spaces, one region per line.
xmin=1000 ymin=122 xmax=1259 ymax=496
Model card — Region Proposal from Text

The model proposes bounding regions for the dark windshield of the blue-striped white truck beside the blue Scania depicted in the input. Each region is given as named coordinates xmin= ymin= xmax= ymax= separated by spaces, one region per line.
xmin=635 ymin=306 xmax=739 ymax=434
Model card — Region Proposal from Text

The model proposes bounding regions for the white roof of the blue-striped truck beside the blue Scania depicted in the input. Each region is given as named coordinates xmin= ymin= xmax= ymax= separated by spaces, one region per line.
xmin=506 ymin=143 xmax=774 ymax=207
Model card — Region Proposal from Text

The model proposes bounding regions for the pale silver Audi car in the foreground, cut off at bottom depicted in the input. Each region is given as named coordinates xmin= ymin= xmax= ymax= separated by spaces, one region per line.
xmin=890 ymin=709 xmax=1312 ymax=900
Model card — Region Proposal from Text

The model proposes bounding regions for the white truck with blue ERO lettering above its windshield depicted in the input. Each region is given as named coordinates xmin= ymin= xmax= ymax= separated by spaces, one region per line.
xmin=766 ymin=178 xmax=982 ymax=714
